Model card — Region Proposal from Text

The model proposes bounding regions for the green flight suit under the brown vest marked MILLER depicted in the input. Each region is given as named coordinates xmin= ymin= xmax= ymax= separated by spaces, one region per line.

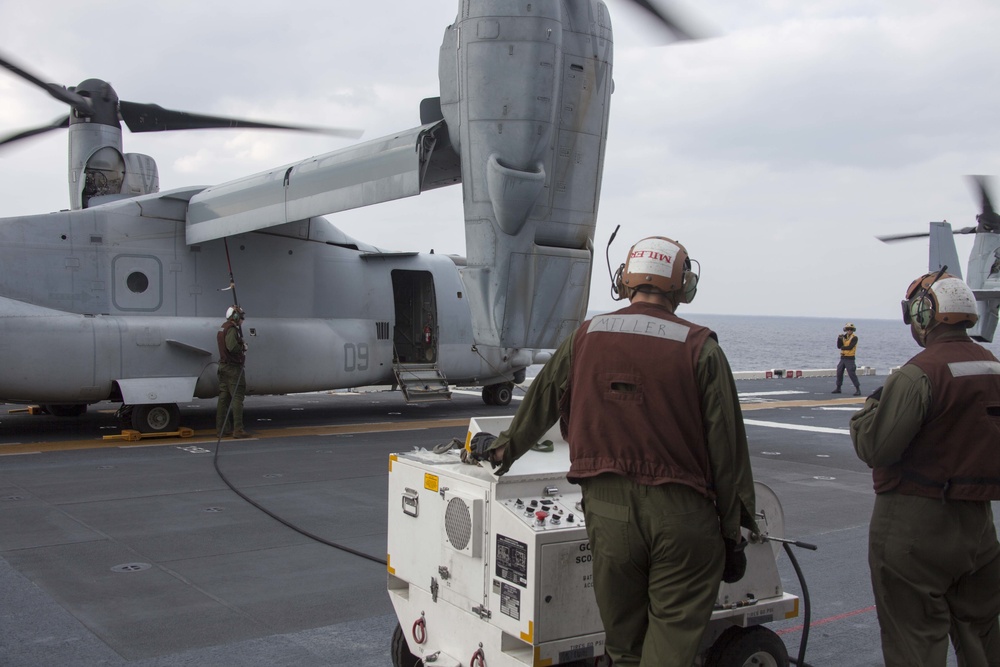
xmin=495 ymin=336 xmax=757 ymax=667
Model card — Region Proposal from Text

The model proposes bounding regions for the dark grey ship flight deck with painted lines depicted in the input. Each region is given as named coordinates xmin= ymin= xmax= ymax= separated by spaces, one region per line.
xmin=0 ymin=377 xmax=988 ymax=667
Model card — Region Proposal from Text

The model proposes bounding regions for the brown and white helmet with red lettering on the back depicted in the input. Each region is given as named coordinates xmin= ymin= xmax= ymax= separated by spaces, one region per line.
xmin=615 ymin=236 xmax=698 ymax=303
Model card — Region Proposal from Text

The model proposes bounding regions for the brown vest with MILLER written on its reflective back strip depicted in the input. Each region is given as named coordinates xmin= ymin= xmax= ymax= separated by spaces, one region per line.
xmin=561 ymin=303 xmax=715 ymax=500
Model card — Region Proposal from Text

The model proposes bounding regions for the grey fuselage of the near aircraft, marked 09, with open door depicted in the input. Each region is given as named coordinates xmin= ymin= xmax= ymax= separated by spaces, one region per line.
xmin=0 ymin=192 xmax=530 ymax=403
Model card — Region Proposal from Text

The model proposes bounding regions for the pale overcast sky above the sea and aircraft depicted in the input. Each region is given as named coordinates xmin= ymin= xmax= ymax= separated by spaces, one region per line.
xmin=0 ymin=0 xmax=1000 ymax=319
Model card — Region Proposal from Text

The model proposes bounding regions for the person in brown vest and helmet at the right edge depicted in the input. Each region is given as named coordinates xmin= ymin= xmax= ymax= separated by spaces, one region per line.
xmin=851 ymin=272 xmax=1000 ymax=667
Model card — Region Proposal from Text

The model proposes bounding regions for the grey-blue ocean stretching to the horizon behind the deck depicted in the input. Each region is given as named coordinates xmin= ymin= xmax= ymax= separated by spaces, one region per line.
xmin=552 ymin=311 xmax=1000 ymax=375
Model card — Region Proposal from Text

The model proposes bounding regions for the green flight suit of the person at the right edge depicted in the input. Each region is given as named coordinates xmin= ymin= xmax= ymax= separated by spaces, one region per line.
xmin=851 ymin=364 xmax=1000 ymax=667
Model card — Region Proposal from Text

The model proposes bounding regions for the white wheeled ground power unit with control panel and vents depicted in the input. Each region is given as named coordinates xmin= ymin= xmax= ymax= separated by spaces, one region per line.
xmin=387 ymin=417 xmax=799 ymax=667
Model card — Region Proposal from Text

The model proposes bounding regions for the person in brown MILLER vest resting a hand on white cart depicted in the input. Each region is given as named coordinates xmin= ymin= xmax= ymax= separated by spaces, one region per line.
xmin=470 ymin=237 xmax=757 ymax=667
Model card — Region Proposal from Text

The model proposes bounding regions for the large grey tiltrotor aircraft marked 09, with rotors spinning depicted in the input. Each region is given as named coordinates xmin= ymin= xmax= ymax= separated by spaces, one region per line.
xmin=0 ymin=0 xmax=686 ymax=432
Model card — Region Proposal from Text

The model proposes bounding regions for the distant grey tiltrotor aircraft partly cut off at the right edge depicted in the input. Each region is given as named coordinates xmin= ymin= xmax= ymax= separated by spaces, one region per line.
xmin=876 ymin=176 xmax=1000 ymax=343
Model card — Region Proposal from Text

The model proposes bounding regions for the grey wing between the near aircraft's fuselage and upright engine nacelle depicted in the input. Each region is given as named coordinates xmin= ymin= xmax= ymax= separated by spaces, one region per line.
xmin=186 ymin=121 xmax=461 ymax=244
